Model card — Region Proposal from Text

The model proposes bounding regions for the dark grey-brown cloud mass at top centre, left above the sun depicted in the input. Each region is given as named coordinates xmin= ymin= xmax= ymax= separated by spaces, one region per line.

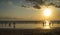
xmin=26 ymin=0 xmax=44 ymax=9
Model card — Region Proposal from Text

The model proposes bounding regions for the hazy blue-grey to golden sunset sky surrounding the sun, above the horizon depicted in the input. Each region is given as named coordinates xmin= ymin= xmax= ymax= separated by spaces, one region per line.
xmin=0 ymin=0 xmax=60 ymax=20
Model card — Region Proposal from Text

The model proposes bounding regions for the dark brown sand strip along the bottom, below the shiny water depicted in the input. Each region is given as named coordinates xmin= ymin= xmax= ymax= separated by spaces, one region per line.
xmin=0 ymin=28 xmax=60 ymax=35
